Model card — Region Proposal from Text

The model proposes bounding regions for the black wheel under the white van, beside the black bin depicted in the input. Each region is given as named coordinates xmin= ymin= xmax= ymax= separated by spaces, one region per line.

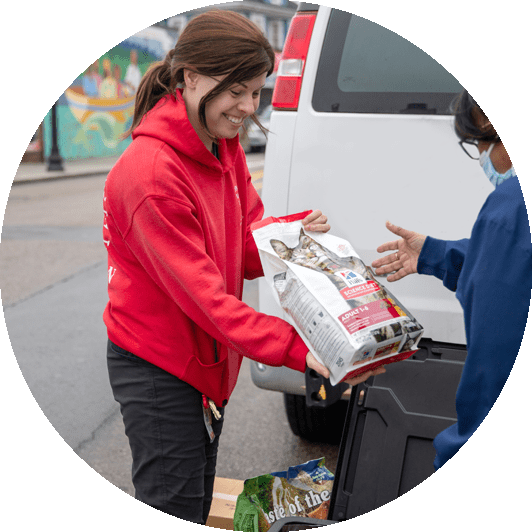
xmin=284 ymin=393 xmax=349 ymax=445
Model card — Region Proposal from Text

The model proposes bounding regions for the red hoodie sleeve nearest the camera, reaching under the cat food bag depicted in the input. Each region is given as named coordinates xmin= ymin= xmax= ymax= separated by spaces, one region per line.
xmin=125 ymin=197 xmax=308 ymax=372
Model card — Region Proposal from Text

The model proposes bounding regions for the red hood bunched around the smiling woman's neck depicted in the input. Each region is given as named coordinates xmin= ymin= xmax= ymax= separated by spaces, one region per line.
xmin=132 ymin=89 xmax=240 ymax=172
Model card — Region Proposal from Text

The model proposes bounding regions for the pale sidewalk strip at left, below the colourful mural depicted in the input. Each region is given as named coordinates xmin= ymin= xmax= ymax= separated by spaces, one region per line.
xmin=13 ymin=156 xmax=118 ymax=185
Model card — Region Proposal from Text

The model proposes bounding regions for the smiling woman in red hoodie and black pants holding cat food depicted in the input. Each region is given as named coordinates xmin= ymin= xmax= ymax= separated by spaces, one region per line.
xmin=104 ymin=11 xmax=383 ymax=524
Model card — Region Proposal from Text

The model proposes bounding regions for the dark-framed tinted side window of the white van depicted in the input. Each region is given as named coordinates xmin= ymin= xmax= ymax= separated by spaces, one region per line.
xmin=312 ymin=9 xmax=462 ymax=114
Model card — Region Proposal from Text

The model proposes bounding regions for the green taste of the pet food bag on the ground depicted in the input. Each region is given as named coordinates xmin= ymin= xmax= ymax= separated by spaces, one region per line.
xmin=233 ymin=458 xmax=334 ymax=532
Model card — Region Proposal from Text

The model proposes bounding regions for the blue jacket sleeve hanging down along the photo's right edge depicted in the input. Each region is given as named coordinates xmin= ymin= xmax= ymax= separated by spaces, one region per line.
xmin=434 ymin=214 xmax=532 ymax=469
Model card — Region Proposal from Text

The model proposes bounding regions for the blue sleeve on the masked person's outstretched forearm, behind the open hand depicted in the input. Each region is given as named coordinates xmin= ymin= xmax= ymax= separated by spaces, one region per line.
xmin=417 ymin=236 xmax=469 ymax=292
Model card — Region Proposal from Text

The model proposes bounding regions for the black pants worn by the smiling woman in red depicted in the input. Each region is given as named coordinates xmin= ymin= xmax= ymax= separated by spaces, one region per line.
xmin=107 ymin=342 xmax=223 ymax=524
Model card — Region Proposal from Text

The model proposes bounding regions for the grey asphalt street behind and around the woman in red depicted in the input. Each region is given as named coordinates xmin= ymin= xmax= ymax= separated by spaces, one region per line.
xmin=0 ymin=154 xmax=338 ymax=502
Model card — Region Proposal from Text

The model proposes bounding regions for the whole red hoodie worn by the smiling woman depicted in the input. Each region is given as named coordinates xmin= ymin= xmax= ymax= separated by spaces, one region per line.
xmin=103 ymin=91 xmax=308 ymax=406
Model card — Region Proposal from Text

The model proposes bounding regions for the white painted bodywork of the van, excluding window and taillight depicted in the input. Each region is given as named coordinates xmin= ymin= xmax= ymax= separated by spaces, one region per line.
xmin=255 ymin=7 xmax=493 ymax=393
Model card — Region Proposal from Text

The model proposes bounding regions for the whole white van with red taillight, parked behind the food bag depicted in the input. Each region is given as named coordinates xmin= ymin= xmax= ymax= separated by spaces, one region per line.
xmin=252 ymin=3 xmax=493 ymax=443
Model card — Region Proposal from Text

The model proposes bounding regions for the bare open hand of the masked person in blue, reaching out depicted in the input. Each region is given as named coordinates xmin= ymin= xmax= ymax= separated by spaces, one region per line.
xmin=371 ymin=222 xmax=427 ymax=282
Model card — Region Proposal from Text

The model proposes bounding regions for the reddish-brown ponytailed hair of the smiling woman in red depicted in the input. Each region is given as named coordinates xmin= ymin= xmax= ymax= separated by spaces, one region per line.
xmin=127 ymin=10 xmax=275 ymax=139
